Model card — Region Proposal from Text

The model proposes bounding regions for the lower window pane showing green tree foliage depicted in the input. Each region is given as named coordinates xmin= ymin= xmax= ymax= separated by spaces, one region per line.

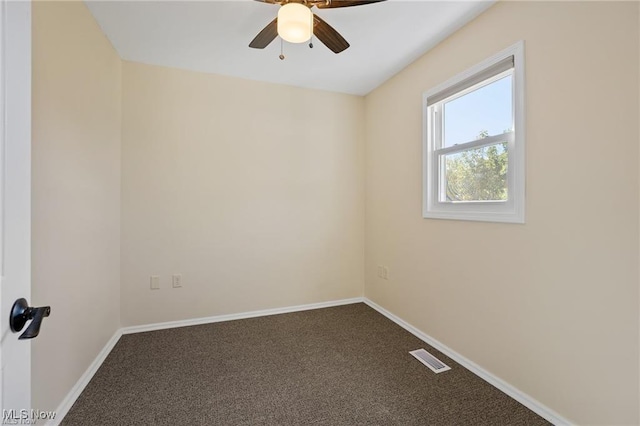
xmin=440 ymin=142 xmax=508 ymax=202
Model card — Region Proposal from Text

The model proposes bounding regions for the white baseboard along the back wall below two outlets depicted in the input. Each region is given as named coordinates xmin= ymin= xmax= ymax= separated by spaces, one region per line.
xmin=122 ymin=297 xmax=364 ymax=334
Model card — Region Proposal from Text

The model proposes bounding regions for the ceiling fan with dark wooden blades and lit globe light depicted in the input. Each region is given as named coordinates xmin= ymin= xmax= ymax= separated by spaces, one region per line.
xmin=249 ymin=0 xmax=385 ymax=55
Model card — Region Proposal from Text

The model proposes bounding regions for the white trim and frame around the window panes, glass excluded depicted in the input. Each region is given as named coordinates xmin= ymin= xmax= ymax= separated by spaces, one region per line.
xmin=422 ymin=41 xmax=525 ymax=223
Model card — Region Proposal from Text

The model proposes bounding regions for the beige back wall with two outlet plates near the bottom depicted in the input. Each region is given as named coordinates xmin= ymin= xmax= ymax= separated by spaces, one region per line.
xmin=121 ymin=62 xmax=364 ymax=325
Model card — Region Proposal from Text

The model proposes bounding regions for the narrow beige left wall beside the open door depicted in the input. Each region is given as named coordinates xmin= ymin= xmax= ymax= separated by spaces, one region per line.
xmin=31 ymin=2 xmax=121 ymax=410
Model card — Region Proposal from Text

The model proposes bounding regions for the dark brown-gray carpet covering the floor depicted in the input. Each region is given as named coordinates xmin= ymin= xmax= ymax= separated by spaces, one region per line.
xmin=62 ymin=303 xmax=549 ymax=426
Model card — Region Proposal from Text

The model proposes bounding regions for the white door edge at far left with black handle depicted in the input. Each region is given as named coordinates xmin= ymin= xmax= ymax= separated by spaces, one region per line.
xmin=0 ymin=0 xmax=31 ymax=412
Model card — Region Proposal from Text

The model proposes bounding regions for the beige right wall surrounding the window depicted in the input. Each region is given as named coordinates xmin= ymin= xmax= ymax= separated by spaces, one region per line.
xmin=365 ymin=2 xmax=639 ymax=424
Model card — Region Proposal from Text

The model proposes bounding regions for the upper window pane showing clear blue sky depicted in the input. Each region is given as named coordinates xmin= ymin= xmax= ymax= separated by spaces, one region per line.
xmin=442 ymin=75 xmax=513 ymax=147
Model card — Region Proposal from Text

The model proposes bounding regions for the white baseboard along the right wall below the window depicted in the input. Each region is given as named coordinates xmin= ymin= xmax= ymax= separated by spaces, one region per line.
xmin=364 ymin=297 xmax=572 ymax=425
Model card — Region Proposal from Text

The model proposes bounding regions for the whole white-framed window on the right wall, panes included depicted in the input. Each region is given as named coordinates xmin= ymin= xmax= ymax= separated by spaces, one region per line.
xmin=423 ymin=42 xmax=525 ymax=223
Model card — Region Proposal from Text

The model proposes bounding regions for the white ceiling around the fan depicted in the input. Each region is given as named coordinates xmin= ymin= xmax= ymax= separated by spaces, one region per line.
xmin=86 ymin=0 xmax=494 ymax=95
